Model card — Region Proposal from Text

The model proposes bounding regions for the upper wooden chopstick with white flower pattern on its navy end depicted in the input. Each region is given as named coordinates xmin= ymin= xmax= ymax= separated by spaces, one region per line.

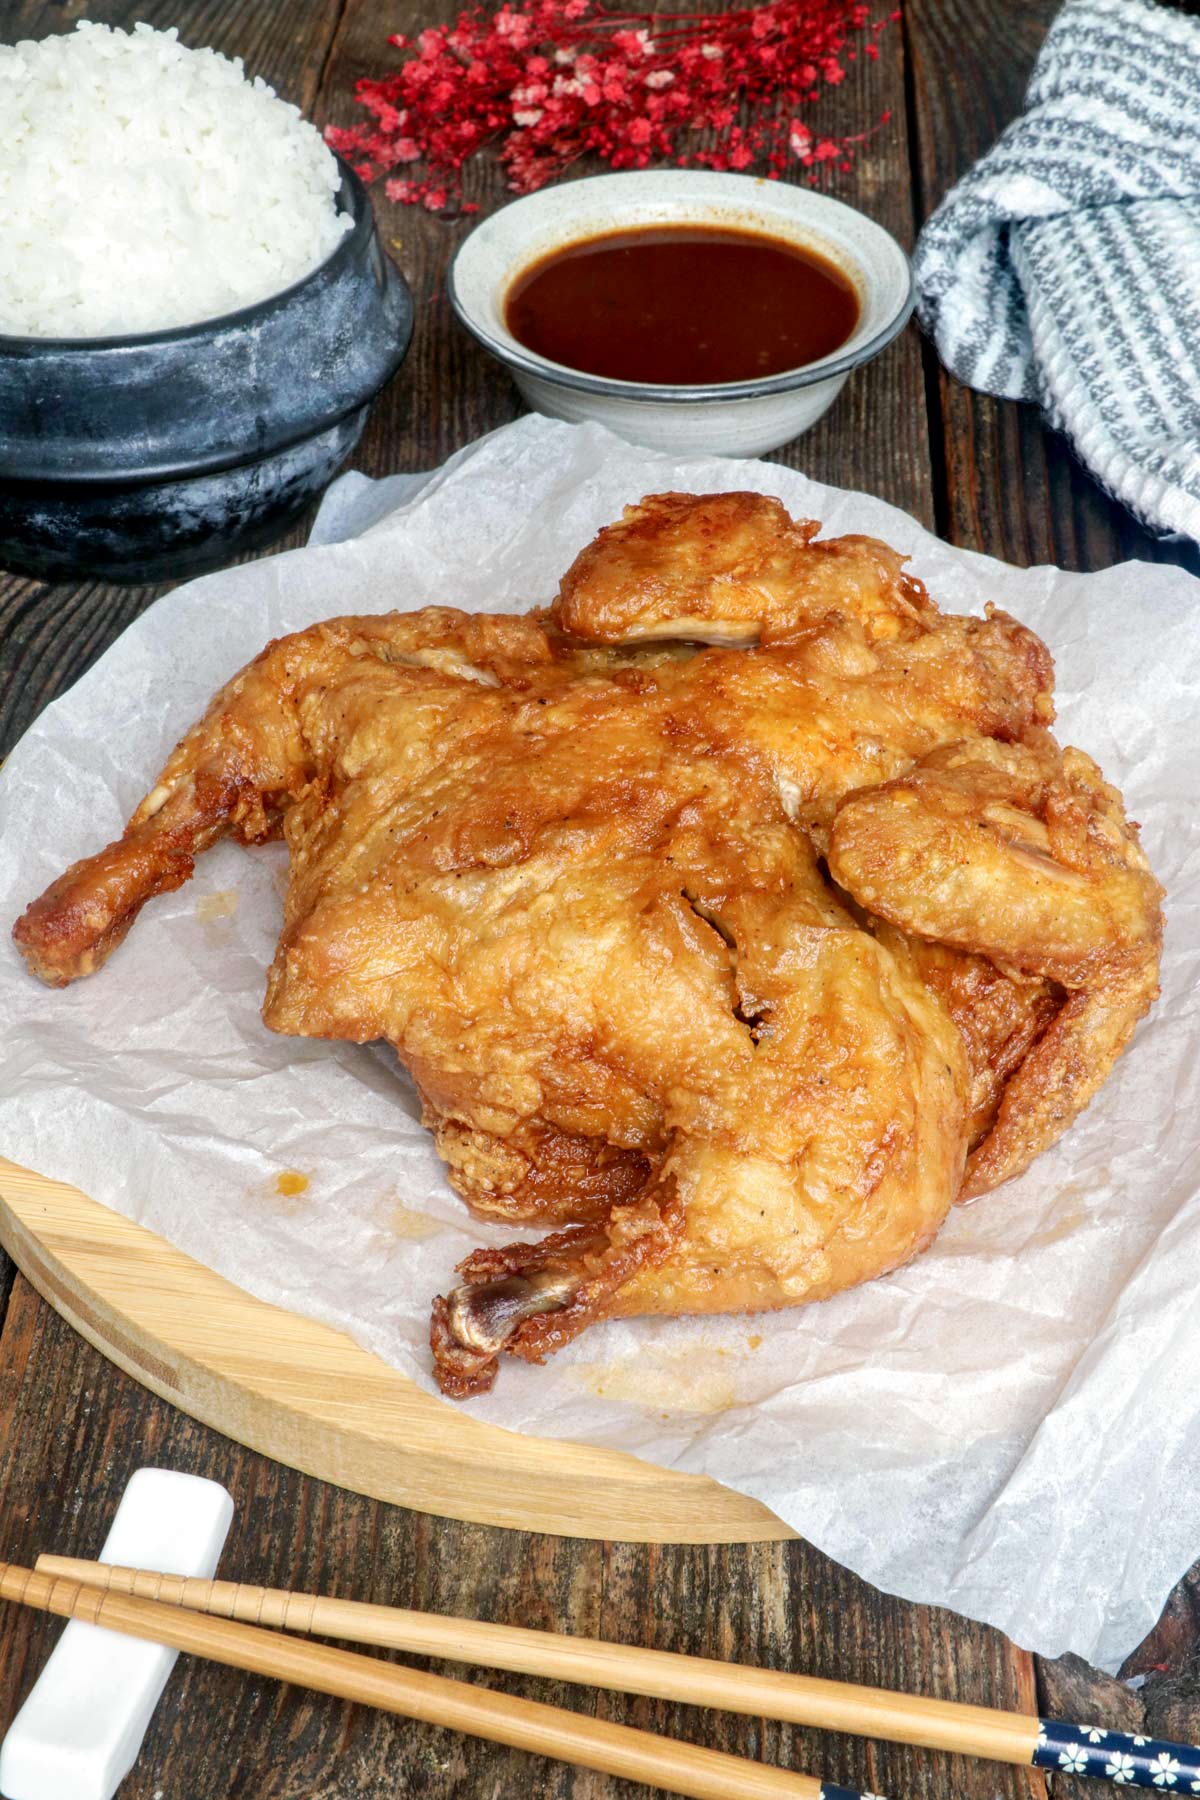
xmin=38 ymin=1555 xmax=1200 ymax=1795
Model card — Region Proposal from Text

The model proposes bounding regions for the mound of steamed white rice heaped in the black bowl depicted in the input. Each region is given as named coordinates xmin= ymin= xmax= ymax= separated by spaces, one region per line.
xmin=0 ymin=21 xmax=349 ymax=337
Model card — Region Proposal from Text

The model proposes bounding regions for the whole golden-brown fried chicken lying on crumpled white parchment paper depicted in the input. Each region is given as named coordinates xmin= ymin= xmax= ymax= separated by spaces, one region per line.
xmin=14 ymin=493 xmax=1162 ymax=1397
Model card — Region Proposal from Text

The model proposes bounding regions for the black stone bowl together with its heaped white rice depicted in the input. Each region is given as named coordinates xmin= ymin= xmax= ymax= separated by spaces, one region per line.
xmin=0 ymin=23 xmax=412 ymax=581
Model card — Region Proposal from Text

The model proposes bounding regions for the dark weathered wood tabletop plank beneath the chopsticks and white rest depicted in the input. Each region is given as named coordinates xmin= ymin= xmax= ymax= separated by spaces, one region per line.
xmin=0 ymin=1278 xmax=1043 ymax=1800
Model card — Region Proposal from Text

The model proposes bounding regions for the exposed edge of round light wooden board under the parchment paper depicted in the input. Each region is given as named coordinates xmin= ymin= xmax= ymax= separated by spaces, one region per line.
xmin=0 ymin=1157 xmax=793 ymax=1544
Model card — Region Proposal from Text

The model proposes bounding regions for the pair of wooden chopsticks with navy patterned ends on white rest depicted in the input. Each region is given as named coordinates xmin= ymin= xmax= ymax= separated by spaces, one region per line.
xmin=0 ymin=1555 xmax=1200 ymax=1800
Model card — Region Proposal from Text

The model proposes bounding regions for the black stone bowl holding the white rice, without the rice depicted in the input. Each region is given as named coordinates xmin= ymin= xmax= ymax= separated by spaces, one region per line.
xmin=0 ymin=164 xmax=412 ymax=581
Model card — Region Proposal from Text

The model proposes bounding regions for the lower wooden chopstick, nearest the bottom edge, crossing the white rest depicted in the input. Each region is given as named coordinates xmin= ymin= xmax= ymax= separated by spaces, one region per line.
xmin=0 ymin=1562 xmax=862 ymax=1800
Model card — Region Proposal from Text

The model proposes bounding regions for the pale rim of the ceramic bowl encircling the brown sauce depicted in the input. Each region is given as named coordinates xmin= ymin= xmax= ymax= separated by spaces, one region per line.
xmin=448 ymin=169 xmax=916 ymax=403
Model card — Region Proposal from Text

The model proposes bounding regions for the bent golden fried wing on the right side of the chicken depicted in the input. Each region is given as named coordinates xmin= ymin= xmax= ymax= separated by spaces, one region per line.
xmin=829 ymin=733 xmax=1162 ymax=1199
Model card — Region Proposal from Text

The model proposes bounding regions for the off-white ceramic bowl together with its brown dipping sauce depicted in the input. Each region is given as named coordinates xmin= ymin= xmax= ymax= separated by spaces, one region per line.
xmin=450 ymin=169 xmax=914 ymax=455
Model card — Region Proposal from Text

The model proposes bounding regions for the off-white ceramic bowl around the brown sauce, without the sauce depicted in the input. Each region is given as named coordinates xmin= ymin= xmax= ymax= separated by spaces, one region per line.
xmin=450 ymin=169 xmax=914 ymax=455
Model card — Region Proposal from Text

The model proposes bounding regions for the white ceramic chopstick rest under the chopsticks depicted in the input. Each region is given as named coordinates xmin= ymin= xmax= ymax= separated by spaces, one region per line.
xmin=0 ymin=1469 xmax=234 ymax=1800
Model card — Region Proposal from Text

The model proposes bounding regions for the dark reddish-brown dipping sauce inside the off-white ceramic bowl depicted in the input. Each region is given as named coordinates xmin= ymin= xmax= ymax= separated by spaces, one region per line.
xmin=506 ymin=225 xmax=858 ymax=387
